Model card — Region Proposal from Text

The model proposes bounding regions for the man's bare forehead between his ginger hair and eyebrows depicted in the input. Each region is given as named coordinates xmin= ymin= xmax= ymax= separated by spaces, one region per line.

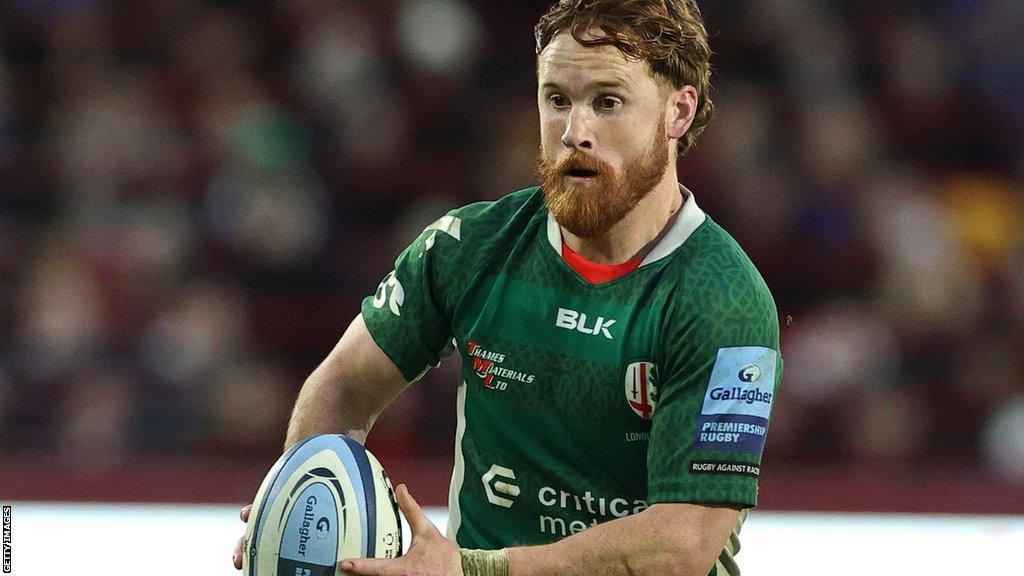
xmin=537 ymin=32 xmax=649 ymax=85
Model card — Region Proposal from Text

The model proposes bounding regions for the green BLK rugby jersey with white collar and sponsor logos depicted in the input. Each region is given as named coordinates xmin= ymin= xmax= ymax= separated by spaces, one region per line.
xmin=362 ymin=188 xmax=782 ymax=574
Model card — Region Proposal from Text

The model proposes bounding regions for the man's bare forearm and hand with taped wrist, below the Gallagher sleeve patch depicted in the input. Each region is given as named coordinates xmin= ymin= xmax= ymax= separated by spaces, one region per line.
xmin=340 ymin=486 xmax=739 ymax=576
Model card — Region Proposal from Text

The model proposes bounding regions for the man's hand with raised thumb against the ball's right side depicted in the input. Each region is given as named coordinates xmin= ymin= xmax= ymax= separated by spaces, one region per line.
xmin=339 ymin=484 xmax=463 ymax=576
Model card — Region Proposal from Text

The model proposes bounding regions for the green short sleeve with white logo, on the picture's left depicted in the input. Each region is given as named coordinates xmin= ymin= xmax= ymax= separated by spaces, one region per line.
xmin=362 ymin=214 xmax=461 ymax=381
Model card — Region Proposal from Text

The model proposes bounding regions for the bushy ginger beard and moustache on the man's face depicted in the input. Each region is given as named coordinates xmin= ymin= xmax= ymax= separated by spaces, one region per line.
xmin=538 ymin=123 xmax=669 ymax=238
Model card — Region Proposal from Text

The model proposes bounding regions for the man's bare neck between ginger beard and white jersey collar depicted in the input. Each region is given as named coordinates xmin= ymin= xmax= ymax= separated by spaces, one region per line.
xmin=558 ymin=163 xmax=684 ymax=264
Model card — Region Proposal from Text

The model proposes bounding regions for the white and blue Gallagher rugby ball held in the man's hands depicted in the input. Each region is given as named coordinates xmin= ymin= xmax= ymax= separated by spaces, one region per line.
xmin=242 ymin=435 xmax=401 ymax=576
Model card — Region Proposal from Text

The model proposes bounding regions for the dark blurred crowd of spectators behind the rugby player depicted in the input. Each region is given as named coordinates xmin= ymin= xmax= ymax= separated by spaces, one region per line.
xmin=0 ymin=0 xmax=1024 ymax=479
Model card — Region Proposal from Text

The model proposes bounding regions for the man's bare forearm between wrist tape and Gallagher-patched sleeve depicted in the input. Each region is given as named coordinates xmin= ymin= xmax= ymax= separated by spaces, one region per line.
xmin=509 ymin=504 xmax=738 ymax=576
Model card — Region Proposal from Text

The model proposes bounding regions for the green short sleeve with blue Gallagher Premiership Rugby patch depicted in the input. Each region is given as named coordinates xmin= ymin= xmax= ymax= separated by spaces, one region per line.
xmin=648 ymin=272 xmax=782 ymax=507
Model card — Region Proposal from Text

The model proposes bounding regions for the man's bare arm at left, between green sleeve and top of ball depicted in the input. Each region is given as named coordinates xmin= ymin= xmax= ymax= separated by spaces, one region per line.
xmin=285 ymin=314 xmax=409 ymax=450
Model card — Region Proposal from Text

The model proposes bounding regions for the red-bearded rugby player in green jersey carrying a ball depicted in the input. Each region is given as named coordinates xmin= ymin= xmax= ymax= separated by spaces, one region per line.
xmin=237 ymin=0 xmax=782 ymax=576
